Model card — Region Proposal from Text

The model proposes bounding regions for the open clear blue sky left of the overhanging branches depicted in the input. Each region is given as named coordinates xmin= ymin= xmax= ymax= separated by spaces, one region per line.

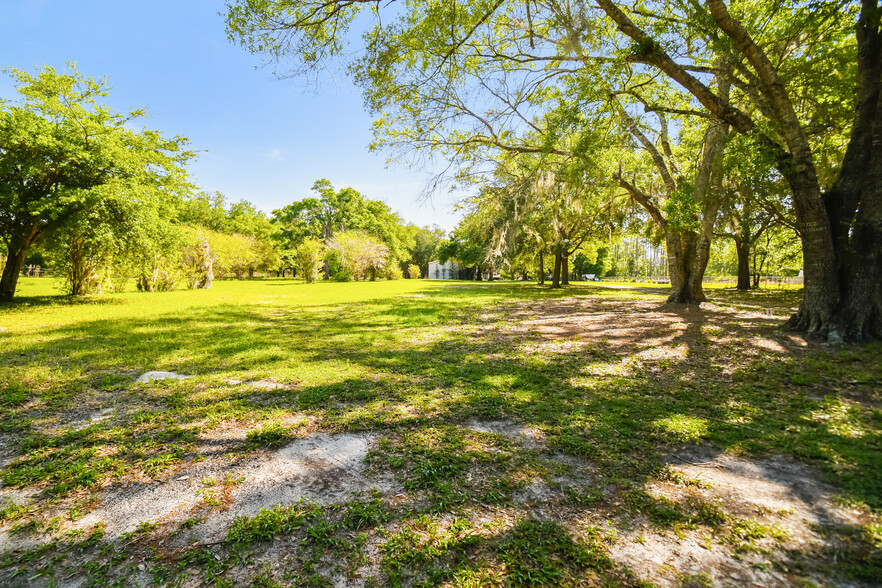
xmin=0 ymin=0 xmax=459 ymax=230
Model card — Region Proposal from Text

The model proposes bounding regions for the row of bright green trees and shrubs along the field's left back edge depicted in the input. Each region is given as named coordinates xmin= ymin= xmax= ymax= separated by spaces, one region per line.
xmin=0 ymin=65 xmax=444 ymax=301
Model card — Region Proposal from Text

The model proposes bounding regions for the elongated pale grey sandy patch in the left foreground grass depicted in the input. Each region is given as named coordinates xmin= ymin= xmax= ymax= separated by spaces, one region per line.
xmin=0 ymin=433 xmax=394 ymax=549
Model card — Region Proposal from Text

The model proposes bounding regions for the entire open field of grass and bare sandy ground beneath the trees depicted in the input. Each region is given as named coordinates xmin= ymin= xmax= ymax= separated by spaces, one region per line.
xmin=0 ymin=279 xmax=882 ymax=586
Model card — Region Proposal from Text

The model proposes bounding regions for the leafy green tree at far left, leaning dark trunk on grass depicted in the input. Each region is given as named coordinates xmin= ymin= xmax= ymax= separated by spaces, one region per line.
xmin=0 ymin=66 xmax=193 ymax=300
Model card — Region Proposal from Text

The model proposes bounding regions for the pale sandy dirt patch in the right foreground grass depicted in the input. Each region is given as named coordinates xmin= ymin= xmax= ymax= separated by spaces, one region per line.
xmin=610 ymin=447 xmax=869 ymax=587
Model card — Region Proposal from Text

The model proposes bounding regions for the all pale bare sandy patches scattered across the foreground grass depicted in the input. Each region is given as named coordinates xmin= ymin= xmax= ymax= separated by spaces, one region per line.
xmin=0 ymin=421 xmax=866 ymax=587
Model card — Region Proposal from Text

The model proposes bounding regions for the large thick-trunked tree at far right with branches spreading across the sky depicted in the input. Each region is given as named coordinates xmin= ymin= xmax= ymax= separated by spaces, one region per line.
xmin=227 ymin=0 xmax=882 ymax=341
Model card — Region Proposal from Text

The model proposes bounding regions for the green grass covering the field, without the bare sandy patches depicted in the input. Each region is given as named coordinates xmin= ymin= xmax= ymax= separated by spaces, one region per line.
xmin=0 ymin=278 xmax=882 ymax=586
